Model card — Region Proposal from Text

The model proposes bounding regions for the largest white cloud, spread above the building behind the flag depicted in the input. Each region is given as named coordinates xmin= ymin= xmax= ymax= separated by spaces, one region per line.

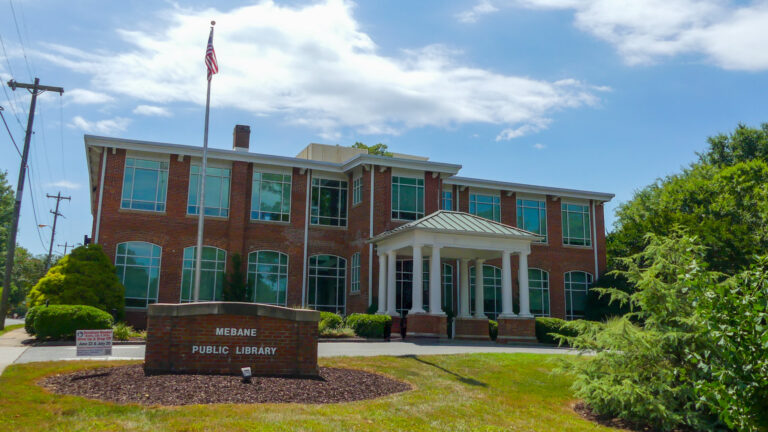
xmin=39 ymin=0 xmax=598 ymax=137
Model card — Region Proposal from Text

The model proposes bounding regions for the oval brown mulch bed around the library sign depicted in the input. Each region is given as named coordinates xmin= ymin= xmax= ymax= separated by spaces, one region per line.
xmin=39 ymin=364 xmax=411 ymax=405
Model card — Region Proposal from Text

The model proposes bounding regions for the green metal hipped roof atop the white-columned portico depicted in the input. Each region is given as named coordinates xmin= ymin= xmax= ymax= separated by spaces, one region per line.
xmin=369 ymin=210 xmax=542 ymax=243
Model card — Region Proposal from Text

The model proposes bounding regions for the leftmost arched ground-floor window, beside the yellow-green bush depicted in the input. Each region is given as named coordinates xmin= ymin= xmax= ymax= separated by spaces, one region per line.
xmin=115 ymin=242 xmax=162 ymax=308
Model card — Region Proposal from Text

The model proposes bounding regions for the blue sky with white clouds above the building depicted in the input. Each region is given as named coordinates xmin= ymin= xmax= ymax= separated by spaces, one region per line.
xmin=0 ymin=0 xmax=768 ymax=253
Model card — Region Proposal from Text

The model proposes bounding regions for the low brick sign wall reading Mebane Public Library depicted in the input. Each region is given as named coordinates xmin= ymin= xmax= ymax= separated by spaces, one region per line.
xmin=144 ymin=302 xmax=320 ymax=376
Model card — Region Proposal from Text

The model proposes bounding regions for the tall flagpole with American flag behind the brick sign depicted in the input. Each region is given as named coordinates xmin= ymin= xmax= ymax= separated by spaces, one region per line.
xmin=192 ymin=21 xmax=219 ymax=302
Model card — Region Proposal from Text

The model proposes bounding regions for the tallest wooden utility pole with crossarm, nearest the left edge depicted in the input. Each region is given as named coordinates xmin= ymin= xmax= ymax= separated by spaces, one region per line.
xmin=0 ymin=78 xmax=64 ymax=330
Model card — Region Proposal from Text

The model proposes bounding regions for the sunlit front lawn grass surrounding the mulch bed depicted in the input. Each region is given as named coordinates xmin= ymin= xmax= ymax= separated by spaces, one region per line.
xmin=0 ymin=354 xmax=614 ymax=432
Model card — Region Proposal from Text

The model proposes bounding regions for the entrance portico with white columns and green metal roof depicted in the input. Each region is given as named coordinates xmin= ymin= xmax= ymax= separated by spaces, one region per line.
xmin=369 ymin=210 xmax=539 ymax=340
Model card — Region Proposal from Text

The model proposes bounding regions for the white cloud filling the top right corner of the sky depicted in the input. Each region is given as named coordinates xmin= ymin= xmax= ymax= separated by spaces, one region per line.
xmin=456 ymin=0 xmax=768 ymax=71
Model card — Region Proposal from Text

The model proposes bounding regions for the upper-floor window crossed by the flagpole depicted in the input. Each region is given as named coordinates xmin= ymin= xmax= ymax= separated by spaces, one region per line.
xmin=187 ymin=165 xmax=230 ymax=217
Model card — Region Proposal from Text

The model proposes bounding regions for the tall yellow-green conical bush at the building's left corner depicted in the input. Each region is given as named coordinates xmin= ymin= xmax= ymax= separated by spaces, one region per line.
xmin=29 ymin=244 xmax=125 ymax=319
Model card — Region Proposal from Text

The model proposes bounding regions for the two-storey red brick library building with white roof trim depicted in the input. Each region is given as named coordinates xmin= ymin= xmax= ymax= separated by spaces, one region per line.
xmin=85 ymin=126 xmax=613 ymax=334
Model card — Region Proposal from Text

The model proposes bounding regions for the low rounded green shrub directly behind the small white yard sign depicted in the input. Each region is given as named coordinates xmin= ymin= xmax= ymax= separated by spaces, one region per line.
xmin=35 ymin=305 xmax=112 ymax=339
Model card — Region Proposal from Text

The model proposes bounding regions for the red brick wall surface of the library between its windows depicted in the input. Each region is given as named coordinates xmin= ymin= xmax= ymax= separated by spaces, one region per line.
xmin=90 ymin=130 xmax=605 ymax=328
